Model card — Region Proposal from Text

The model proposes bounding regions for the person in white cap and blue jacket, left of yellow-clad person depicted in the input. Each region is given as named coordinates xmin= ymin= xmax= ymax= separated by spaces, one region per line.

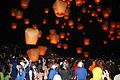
xmin=76 ymin=61 xmax=87 ymax=80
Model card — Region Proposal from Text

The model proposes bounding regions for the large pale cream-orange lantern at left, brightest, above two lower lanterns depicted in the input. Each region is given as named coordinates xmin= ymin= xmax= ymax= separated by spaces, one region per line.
xmin=25 ymin=28 xmax=39 ymax=45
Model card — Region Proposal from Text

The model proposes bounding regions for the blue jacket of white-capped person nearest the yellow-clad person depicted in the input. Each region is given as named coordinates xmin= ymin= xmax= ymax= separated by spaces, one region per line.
xmin=76 ymin=67 xmax=87 ymax=80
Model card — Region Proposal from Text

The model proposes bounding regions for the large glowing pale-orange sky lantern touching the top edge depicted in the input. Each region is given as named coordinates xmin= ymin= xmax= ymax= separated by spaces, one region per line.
xmin=53 ymin=0 xmax=67 ymax=17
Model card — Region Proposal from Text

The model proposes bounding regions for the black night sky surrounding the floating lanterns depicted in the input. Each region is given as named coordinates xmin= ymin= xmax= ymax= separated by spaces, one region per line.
xmin=0 ymin=0 xmax=120 ymax=57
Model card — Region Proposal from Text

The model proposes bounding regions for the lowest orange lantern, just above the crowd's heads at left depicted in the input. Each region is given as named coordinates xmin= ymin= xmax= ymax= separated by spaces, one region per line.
xmin=27 ymin=48 xmax=39 ymax=62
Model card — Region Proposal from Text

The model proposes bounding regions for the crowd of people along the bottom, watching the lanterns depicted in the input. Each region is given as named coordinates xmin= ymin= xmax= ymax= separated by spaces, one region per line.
xmin=0 ymin=44 xmax=120 ymax=80
